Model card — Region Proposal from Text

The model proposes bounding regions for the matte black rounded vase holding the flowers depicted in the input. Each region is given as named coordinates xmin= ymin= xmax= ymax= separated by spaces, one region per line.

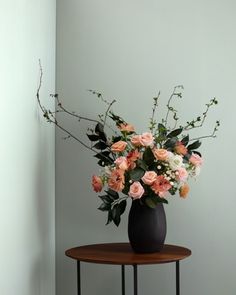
xmin=128 ymin=200 xmax=166 ymax=253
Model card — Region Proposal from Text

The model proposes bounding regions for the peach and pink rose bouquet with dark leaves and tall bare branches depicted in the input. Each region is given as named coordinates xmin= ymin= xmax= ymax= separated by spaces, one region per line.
xmin=37 ymin=67 xmax=220 ymax=226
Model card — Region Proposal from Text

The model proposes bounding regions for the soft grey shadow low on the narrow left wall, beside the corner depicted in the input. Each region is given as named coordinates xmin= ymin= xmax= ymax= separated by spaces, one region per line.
xmin=30 ymin=114 xmax=55 ymax=295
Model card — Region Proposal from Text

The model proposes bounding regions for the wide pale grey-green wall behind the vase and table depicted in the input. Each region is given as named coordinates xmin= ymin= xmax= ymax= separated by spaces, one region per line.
xmin=56 ymin=0 xmax=236 ymax=295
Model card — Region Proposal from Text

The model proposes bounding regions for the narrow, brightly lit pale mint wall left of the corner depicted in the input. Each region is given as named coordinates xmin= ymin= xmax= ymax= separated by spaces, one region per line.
xmin=0 ymin=0 xmax=56 ymax=295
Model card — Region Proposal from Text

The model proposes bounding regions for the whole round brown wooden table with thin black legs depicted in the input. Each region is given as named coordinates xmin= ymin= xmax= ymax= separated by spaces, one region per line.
xmin=65 ymin=243 xmax=191 ymax=295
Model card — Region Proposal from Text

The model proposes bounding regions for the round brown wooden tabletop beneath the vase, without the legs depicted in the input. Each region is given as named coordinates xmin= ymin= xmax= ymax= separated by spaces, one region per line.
xmin=65 ymin=243 xmax=191 ymax=265
